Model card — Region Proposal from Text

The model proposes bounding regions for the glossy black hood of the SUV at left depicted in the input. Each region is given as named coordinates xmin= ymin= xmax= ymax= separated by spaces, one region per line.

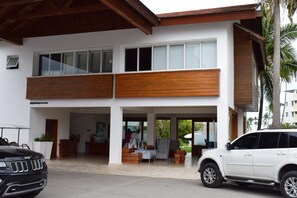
xmin=0 ymin=146 xmax=41 ymax=159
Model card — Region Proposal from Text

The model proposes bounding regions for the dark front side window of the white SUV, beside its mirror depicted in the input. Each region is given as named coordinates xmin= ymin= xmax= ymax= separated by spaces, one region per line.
xmin=232 ymin=133 xmax=258 ymax=150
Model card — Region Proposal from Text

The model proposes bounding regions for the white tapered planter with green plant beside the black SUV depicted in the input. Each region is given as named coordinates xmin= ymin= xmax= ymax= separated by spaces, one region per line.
xmin=33 ymin=134 xmax=53 ymax=159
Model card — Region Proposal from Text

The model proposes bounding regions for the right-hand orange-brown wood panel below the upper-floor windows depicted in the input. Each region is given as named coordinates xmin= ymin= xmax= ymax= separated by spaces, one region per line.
xmin=115 ymin=69 xmax=220 ymax=98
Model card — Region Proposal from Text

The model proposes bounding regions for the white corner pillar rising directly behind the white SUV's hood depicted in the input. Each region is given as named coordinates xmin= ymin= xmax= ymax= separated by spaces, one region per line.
xmin=217 ymin=103 xmax=230 ymax=149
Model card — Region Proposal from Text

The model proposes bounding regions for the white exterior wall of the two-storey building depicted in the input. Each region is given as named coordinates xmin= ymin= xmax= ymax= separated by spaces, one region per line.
xmin=0 ymin=21 xmax=234 ymax=163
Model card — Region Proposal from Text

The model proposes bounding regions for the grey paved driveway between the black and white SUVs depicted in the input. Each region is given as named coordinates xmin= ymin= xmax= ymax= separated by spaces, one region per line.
xmin=32 ymin=170 xmax=281 ymax=198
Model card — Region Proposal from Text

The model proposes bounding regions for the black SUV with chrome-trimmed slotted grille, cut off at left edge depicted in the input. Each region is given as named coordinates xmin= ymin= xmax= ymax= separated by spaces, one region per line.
xmin=0 ymin=138 xmax=48 ymax=198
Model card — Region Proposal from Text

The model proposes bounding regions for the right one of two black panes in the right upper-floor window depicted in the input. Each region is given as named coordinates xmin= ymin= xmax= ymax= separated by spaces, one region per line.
xmin=139 ymin=47 xmax=152 ymax=71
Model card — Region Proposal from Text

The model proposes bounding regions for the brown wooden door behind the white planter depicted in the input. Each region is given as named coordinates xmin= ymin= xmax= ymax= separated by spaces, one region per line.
xmin=45 ymin=119 xmax=58 ymax=159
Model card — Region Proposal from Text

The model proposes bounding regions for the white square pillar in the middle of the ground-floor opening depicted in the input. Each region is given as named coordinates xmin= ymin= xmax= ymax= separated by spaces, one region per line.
xmin=109 ymin=106 xmax=123 ymax=164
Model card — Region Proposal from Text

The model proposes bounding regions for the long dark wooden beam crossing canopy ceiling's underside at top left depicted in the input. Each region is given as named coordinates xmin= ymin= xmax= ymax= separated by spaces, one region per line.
xmin=9 ymin=4 xmax=107 ymax=21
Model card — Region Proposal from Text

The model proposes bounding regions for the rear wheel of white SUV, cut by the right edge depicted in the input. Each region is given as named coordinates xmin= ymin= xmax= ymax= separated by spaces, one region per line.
xmin=280 ymin=171 xmax=297 ymax=198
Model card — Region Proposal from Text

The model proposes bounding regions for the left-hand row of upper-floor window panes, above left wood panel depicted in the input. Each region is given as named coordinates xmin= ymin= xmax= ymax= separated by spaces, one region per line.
xmin=39 ymin=49 xmax=112 ymax=76
